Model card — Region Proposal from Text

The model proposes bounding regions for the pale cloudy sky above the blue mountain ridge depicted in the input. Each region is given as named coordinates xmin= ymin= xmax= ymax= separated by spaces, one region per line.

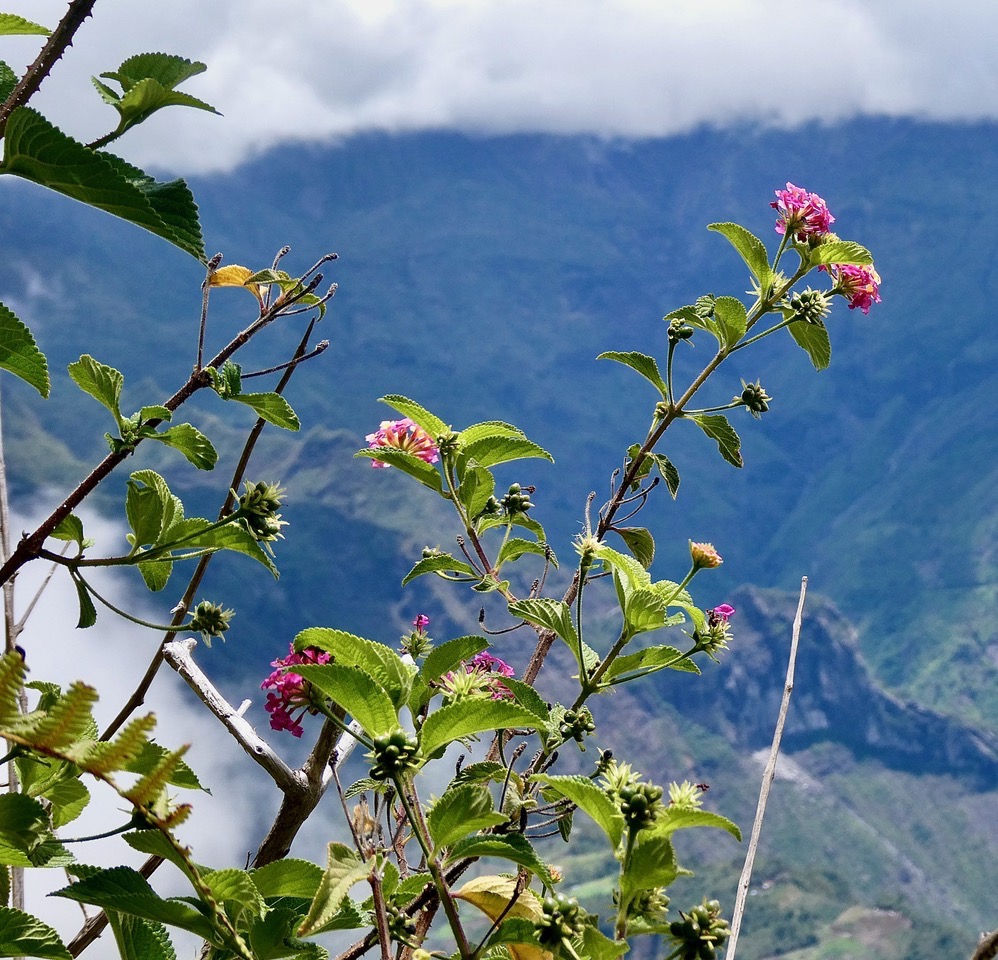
xmin=0 ymin=0 xmax=998 ymax=173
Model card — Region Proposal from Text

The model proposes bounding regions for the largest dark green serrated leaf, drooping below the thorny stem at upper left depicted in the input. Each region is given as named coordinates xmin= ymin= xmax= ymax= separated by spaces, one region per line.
xmin=0 ymin=107 xmax=205 ymax=263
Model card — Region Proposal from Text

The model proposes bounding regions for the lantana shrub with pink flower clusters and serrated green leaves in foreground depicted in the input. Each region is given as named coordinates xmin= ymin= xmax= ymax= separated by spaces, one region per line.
xmin=0 ymin=3 xmax=900 ymax=960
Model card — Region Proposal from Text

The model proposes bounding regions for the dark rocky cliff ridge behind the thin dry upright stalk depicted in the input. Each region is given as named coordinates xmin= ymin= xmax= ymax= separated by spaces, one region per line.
xmin=656 ymin=588 xmax=998 ymax=789
